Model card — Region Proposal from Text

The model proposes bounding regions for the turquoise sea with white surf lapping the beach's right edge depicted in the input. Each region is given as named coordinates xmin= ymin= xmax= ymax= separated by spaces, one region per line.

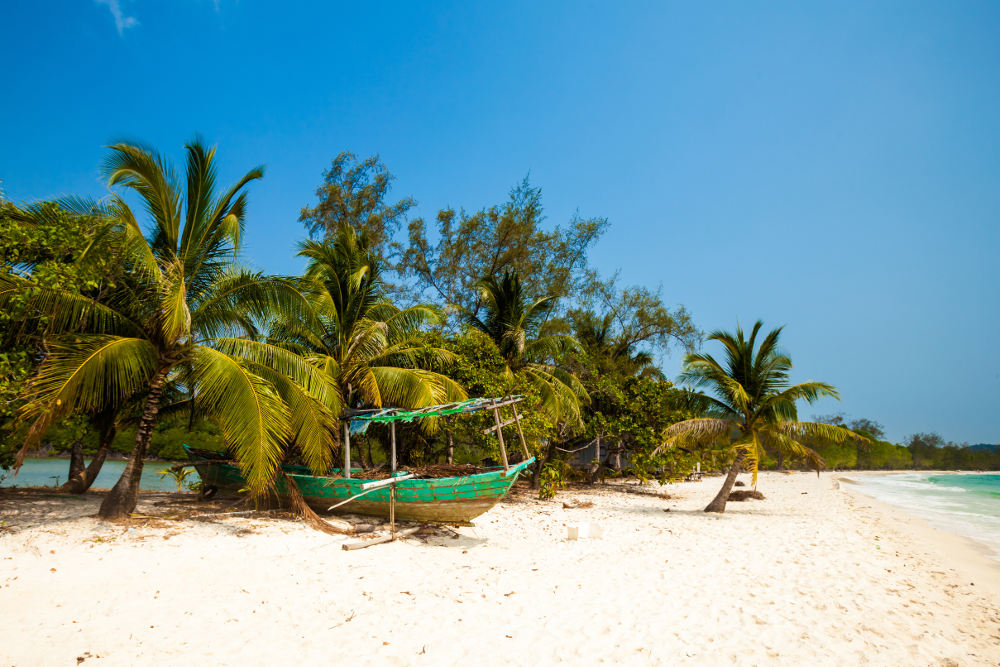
xmin=852 ymin=473 xmax=1000 ymax=560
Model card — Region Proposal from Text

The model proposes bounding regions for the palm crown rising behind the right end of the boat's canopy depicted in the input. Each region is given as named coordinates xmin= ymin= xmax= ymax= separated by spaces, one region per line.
xmin=459 ymin=269 xmax=588 ymax=422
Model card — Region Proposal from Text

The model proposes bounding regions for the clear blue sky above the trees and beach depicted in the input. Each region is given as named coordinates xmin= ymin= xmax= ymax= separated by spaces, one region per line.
xmin=0 ymin=0 xmax=1000 ymax=442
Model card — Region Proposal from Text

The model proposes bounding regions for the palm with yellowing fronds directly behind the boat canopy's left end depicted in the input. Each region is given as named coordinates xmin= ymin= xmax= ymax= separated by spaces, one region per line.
xmin=270 ymin=225 xmax=466 ymax=463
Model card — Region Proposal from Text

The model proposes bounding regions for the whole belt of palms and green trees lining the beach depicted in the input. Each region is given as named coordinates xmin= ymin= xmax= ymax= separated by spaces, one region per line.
xmin=0 ymin=141 xmax=988 ymax=516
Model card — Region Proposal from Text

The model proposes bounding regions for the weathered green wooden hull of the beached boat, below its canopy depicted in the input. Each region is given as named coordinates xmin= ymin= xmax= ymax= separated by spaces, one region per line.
xmin=184 ymin=445 xmax=535 ymax=525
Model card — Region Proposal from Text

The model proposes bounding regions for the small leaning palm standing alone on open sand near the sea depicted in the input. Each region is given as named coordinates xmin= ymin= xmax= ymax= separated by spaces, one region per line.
xmin=667 ymin=320 xmax=860 ymax=512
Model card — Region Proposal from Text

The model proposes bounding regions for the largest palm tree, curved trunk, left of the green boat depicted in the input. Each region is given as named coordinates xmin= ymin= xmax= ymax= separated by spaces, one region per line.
xmin=0 ymin=140 xmax=327 ymax=518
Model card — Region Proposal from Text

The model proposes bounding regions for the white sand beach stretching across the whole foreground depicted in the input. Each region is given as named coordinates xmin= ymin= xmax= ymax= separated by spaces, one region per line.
xmin=0 ymin=473 xmax=1000 ymax=665
